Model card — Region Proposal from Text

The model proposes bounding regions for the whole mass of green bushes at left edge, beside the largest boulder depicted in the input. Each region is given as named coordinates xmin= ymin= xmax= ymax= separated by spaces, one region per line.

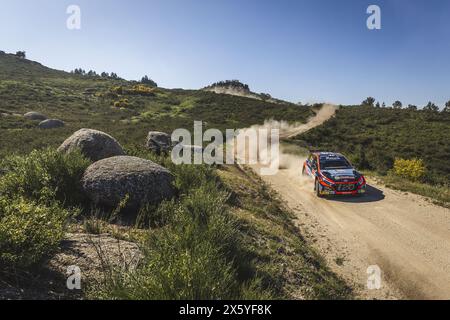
xmin=0 ymin=149 xmax=89 ymax=274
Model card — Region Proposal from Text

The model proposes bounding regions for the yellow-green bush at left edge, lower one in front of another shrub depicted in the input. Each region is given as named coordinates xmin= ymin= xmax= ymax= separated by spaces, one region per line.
xmin=0 ymin=197 xmax=70 ymax=269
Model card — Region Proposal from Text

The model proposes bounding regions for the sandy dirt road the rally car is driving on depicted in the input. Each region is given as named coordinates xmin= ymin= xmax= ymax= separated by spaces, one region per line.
xmin=250 ymin=106 xmax=450 ymax=299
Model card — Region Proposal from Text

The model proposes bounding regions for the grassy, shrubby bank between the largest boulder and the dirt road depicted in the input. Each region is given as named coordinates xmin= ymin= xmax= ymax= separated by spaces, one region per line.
xmin=89 ymin=151 xmax=352 ymax=299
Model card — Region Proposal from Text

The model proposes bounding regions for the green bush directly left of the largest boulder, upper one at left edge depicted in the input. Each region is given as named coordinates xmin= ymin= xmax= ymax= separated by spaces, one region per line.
xmin=0 ymin=148 xmax=90 ymax=205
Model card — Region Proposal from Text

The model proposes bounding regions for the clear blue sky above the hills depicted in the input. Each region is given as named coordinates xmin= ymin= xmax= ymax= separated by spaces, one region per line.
xmin=0 ymin=0 xmax=450 ymax=106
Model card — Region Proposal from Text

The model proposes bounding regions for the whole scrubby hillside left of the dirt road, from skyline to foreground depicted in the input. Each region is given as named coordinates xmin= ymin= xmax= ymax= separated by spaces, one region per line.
xmin=0 ymin=55 xmax=353 ymax=300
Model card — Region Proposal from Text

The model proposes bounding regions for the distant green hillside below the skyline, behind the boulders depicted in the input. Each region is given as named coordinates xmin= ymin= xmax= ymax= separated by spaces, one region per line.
xmin=0 ymin=55 xmax=312 ymax=154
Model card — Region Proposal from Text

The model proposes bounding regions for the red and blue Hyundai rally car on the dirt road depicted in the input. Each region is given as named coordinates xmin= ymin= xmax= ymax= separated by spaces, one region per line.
xmin=303 ymin=152 xmax=366 ymax=197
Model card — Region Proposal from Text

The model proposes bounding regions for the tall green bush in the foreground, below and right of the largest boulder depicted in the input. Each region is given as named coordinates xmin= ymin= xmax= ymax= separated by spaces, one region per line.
xmin=91 ymin=189 xmax=244 ymax=300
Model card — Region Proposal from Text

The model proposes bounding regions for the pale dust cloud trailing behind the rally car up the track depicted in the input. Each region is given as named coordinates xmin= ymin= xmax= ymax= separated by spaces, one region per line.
xmin=235 ymin=104 xmax=338 ymax=176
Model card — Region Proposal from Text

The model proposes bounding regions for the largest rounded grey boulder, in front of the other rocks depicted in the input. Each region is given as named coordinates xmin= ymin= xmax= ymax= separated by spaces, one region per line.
xmin=81 ymin=156 xmax=174 ymax=208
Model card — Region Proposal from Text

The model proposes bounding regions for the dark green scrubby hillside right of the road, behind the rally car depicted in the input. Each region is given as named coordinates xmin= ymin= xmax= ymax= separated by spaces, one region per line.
xmin=293 ymin=107 xmax=450 ymax=184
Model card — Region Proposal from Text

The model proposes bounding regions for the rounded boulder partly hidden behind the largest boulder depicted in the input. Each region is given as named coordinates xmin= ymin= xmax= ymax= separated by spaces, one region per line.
xmin=58 ymin=129 xmax=125 ymax=161
